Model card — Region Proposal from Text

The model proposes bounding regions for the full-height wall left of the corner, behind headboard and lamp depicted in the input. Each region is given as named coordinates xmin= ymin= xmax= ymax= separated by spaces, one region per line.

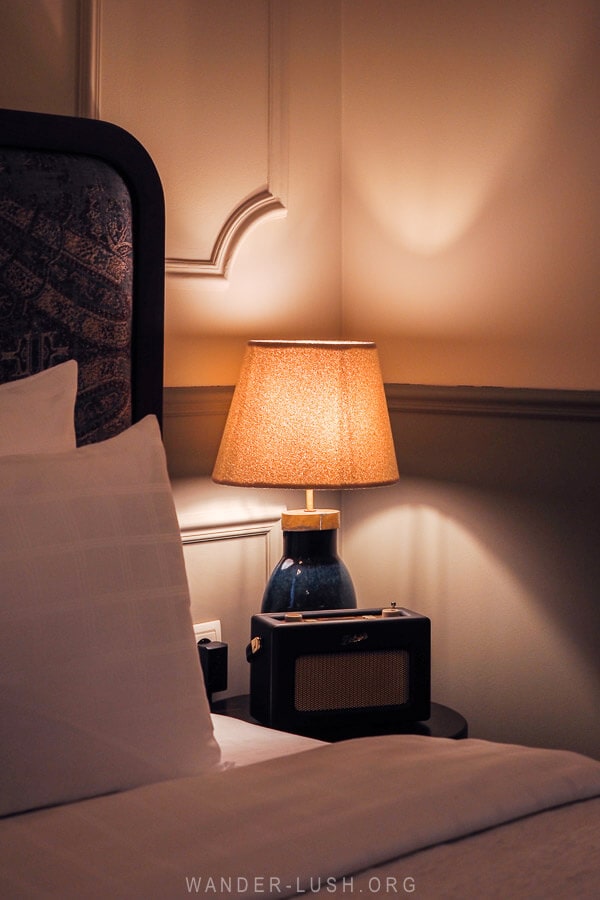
xmin=0 ymin=0 xmax=341 ymax=693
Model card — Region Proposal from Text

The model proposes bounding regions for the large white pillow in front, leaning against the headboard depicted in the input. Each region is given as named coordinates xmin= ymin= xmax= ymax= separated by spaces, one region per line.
xmin=0 ymin=416 xmax=220 ymax=814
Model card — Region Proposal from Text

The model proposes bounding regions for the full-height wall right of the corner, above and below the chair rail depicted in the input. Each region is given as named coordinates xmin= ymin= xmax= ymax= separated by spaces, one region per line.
xmin=342 ymin=0 xmax=600 ymax=756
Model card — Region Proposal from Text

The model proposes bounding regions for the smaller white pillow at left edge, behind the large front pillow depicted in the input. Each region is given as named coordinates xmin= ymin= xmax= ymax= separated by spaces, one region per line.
xmin=0 ymin=359 xmax=77 ymax=456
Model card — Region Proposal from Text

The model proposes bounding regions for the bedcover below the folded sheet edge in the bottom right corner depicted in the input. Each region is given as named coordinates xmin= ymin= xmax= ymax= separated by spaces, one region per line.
xmin=324 ymin=799 xmax=600 ymax=900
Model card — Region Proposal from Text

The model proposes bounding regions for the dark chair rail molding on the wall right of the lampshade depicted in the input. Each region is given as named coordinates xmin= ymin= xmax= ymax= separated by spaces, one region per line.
xmin=386 ymin=384 xmax=600 ymax=421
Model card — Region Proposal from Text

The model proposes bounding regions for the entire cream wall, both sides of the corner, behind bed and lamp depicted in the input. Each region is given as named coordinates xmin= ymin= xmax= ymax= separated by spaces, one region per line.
xmin=0 ymin=0 xmax=600 ymax=756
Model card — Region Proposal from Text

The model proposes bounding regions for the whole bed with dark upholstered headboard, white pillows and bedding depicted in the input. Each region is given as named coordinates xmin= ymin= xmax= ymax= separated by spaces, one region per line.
xmin=0 ymin=111 xmax=600 ymax=900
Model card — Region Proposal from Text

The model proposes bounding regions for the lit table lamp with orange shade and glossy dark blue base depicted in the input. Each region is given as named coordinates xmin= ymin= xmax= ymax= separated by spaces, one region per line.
xmin=212 ymin=341 xmax=398 ymax=614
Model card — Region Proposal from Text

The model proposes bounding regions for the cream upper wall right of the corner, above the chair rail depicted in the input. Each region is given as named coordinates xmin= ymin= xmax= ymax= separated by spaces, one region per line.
xmin=342 ymin=0 xmax=600 ymax=389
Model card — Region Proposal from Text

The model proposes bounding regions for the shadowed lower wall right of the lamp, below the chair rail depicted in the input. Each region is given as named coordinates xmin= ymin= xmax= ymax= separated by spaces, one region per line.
xmin=343 ymin=415 xmax=600 ymax=757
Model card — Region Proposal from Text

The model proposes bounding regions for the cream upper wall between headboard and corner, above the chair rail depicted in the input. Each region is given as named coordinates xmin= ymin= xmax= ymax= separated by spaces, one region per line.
xmin=100 ymin=0 xmax=340 ymax=385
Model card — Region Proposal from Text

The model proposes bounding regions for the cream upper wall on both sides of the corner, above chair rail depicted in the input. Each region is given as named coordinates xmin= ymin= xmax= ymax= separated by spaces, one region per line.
xmin=0 ymin=0 xmax=600 ymax=389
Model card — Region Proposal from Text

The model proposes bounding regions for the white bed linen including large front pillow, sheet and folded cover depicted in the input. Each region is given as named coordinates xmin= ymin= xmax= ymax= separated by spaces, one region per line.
xmin=0 ymin=370 xmax=600 ymax=900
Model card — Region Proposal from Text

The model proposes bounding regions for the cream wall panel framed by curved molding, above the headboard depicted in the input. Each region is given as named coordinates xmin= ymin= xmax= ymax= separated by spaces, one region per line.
xmin=97 ymin=0 xmax=287 ymax=277
